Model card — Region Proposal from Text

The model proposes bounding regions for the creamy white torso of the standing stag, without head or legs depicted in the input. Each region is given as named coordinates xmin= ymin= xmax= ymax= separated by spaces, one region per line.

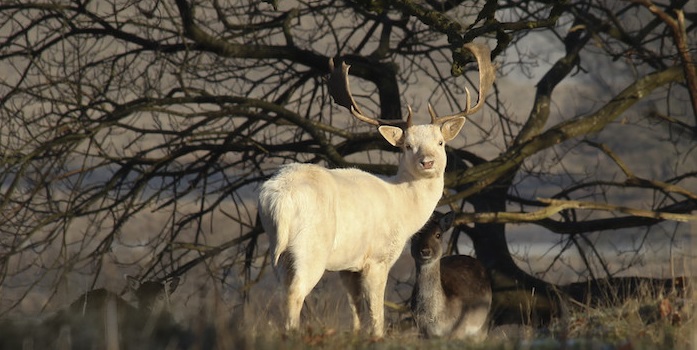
xmin=259 ymin=164 xmax=442 ymax=271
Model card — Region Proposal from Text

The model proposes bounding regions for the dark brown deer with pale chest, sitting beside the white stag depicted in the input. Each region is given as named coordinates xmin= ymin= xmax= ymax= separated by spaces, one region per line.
xmin=411 ymin=212 xmax=491 ymax=340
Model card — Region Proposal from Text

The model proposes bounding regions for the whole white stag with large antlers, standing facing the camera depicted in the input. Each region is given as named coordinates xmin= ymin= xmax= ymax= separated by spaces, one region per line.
xmin=259 ymin=44 xmax=494 ymax=337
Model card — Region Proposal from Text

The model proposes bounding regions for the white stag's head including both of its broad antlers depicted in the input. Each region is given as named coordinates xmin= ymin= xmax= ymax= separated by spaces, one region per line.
xmin=329 ymin=43 xmax=495 ymax=178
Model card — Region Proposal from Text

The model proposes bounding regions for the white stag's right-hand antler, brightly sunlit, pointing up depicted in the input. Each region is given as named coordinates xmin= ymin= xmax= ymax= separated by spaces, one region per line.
xmin=428 ymin=43 xmax=496 ymax=124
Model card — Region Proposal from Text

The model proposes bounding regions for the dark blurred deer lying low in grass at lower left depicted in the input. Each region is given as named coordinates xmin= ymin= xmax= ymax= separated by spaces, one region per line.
xmin=43 ymin=276 xmax=179 ymax=349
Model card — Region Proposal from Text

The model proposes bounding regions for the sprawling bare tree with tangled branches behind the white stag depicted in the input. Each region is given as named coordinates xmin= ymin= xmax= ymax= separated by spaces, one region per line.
xmin=0 ymin=0 xmax=697 ymax=324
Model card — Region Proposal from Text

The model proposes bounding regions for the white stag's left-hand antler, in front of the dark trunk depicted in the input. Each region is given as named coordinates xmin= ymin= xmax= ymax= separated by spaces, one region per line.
xmin=327 ymin=58 xmax=412 ymax=129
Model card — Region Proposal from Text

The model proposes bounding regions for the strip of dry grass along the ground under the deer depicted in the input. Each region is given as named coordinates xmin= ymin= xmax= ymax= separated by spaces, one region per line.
xmin=0 ymin=284 xmax=697 ymax=350
